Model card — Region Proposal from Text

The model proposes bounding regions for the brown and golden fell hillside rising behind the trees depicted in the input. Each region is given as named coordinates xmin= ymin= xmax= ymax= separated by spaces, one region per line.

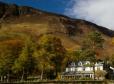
xmin=0 ymin=2 xmax=114 ymax=58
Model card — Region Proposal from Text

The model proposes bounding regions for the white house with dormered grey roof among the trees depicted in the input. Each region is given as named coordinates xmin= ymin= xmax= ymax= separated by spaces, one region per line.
xmin=62 ymin=61 xmax=103 ymax=79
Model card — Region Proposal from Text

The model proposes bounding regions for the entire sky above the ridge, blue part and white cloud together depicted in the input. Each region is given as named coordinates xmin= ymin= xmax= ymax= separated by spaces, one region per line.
xmin=0 ymin=0 xmax=114 ymax=30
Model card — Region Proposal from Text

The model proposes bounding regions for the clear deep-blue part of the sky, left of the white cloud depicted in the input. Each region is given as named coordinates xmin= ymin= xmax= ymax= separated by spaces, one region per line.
xmin=0 ymin=0 xmax=70 ymax=14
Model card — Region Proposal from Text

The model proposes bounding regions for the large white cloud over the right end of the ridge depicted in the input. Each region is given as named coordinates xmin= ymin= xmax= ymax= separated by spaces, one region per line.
xmin=65 ymin=0 xmax=114 ymax=30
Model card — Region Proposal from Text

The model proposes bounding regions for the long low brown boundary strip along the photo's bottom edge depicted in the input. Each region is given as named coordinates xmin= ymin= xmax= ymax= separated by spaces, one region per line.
xmin=0 ymin=80 xmax=107 ymax=84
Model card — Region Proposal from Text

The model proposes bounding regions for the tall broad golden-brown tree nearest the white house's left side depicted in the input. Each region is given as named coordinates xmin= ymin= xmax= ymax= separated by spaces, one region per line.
xmin=39 ymin=35 xmax=66 ymax=79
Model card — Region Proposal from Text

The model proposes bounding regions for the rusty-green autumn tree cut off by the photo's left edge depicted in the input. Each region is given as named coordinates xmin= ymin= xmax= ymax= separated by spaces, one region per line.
xmin=0 ymin=45 xmax=15 ymax=81
